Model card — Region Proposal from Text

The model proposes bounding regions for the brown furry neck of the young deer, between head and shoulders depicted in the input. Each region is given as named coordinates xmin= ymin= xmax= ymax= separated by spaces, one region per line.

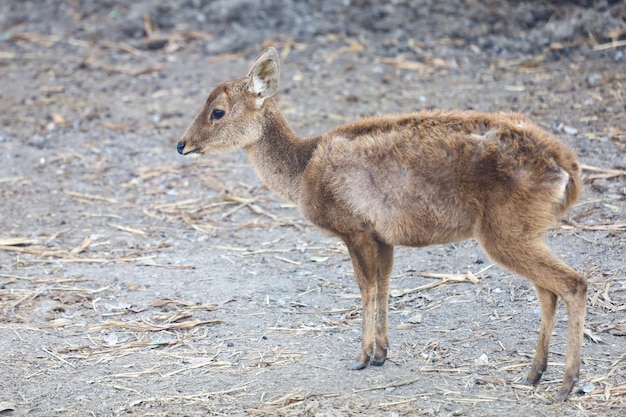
xmin=246 ymin=99 xmax=319 ymax=203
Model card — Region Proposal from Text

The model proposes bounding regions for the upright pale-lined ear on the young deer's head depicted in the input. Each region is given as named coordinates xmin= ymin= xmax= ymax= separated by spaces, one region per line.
xmin=248 ymin=47 xmax=280 ymax=108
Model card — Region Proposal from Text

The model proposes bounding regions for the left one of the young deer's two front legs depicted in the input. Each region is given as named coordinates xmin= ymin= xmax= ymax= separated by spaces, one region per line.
xmin=344 ymin=232 xmax=388 ymax=369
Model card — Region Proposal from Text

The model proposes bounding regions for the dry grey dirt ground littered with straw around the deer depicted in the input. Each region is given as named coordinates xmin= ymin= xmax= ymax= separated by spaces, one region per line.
xmin=0 ymin=0 xmax=626 ymax=417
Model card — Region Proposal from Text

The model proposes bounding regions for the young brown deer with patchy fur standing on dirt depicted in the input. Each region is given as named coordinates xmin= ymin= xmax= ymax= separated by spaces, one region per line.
xmin=177 ymin=48 xmax=587 ymax=400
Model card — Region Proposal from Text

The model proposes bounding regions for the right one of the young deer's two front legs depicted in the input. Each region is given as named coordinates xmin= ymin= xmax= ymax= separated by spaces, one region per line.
xmin=370 ymin=242 xmax=393 ymax=366
